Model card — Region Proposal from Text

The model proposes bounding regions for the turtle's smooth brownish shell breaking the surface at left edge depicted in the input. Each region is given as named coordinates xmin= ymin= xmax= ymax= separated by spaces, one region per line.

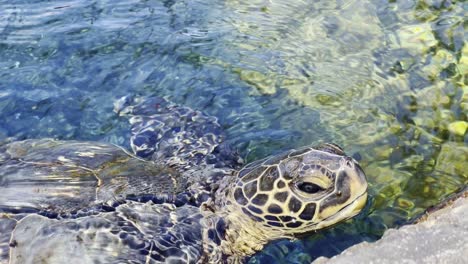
xmin=0 ymin=139 xmax=180 ymax=214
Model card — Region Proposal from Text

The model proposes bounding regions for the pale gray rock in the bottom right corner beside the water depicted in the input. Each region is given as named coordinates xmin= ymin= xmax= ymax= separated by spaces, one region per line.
xmin=314 ymin=195 xmax=468 ymax=264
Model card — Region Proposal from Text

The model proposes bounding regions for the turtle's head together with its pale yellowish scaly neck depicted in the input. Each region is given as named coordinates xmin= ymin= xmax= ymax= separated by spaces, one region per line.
xmin=202 ymin=144 xmax=367 ymax=263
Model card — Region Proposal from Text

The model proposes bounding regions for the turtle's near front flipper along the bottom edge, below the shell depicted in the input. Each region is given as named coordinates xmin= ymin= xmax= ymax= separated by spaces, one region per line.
xmin=10 ymin=202 xmax=207 ymax=264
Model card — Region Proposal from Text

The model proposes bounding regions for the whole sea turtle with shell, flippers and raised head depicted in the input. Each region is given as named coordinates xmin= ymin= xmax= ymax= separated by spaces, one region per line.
xmin=0 ymin=98 xmax=367 ymax=263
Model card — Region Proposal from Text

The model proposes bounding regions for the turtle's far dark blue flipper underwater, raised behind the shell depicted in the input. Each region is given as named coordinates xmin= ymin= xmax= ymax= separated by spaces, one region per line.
xmin=114 ymin=97 xmax=241 ymax=168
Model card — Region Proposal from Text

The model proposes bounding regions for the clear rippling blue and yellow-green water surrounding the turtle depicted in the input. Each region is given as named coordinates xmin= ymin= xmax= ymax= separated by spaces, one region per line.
xmin=0 ymin=0 xmax=468 ymax=263
